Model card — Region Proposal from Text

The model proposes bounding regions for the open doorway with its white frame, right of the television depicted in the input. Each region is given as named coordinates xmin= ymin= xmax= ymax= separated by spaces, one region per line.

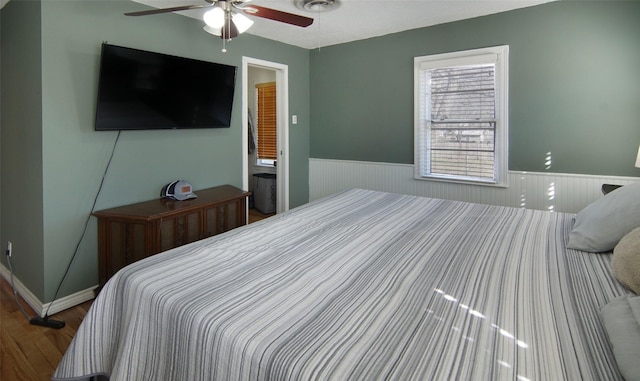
xmin=242 ymin=57 xmax=289 ymax=220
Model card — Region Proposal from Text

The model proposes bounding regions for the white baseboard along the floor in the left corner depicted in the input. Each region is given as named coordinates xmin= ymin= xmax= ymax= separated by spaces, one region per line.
xmin=0 ymin=264 xmax=98 ymax=316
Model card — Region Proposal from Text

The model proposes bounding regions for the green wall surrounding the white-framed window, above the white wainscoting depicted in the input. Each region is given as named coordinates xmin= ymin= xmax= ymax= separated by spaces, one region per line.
xmin=310 ymin=1 xmax=640 ymax=176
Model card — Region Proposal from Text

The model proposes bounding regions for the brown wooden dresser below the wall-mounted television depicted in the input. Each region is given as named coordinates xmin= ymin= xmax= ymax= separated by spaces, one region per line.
xmin=93 ymin=185 xmax=251 ymax=287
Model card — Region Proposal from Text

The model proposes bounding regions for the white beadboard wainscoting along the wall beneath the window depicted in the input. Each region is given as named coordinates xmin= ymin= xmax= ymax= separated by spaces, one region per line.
xmin=309 ymin=159 xmax=640 ymax=213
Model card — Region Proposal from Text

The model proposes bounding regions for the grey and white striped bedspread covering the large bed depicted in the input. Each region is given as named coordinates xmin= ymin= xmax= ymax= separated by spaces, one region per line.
xmin=54 ymin=190 xmax=625 ymax=381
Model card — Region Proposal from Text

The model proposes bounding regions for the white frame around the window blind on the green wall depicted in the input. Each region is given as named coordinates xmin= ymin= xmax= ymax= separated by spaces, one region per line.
xmin=414 ymin=45 xmax=509 ymax=187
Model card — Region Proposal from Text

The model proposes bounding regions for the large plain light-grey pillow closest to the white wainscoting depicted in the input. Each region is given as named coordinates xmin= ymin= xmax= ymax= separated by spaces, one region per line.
xmin=567 ymin=182 xmax=640 ymax=253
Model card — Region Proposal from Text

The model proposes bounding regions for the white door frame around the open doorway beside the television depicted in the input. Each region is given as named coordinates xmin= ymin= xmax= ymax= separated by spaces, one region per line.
xmin=242 ymin=56 xmax=289 ymax=213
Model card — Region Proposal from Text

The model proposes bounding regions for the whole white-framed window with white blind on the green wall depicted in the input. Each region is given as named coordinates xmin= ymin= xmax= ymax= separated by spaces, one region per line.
xmin=414 ymin=46 xmax=509 ymax=186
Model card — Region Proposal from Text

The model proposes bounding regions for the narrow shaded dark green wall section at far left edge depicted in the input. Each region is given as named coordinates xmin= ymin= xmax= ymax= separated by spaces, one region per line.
xmin=0 ymin=0 xmax=45 ymax=295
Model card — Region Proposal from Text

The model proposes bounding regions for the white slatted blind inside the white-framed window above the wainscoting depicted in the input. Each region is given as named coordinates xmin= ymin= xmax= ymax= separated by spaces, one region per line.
xmin=427 ymin=64 xmax=496 ymax=181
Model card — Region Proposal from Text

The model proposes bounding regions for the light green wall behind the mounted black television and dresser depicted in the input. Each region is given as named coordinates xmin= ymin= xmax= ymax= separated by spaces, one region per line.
xmin=1 ymin=0 xmax=309 ymax=302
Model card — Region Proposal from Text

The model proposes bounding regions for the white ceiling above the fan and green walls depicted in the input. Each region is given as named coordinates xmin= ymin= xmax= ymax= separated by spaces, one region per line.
xmin=133 ymin=0 xmax=555 ymax=49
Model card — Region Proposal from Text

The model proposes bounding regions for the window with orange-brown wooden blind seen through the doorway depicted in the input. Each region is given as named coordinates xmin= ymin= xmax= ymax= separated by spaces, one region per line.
xmin=256 ymin=82 xmax=278 ymax=165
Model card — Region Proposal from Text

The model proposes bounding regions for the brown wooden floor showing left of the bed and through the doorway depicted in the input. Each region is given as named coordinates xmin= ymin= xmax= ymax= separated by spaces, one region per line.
xmin=0 ymin=209 xmax=271 ymax=381
